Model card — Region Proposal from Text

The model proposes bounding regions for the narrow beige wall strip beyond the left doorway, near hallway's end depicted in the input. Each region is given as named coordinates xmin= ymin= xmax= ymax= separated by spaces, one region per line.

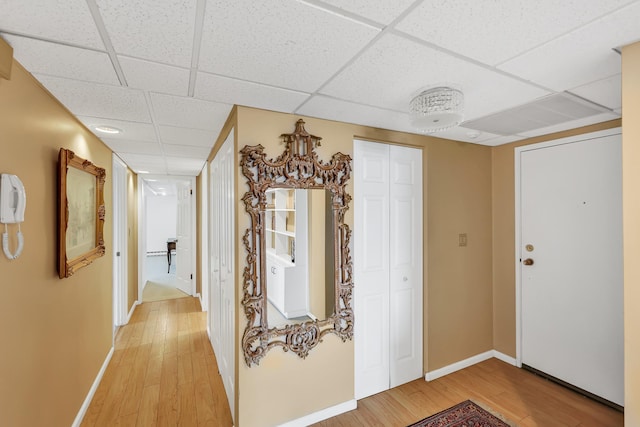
xmin=127 ymin=169 xmax=138 ymax=312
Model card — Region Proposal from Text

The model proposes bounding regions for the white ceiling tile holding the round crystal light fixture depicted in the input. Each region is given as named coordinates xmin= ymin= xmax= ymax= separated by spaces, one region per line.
xmin=322 ymin=34 xmax=548 ymax=119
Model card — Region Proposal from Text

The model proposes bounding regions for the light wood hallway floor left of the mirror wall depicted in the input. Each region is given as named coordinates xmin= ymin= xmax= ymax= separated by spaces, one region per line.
xmin=82 ymin=297 xmax=232 ymax=427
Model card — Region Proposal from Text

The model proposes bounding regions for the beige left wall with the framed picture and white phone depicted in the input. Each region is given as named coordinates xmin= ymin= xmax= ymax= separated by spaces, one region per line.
xmin=0 ymin=62 xmax=112 ymax=426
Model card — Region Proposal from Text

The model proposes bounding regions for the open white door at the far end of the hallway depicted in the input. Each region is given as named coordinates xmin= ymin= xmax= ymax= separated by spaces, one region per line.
xmin=176 ymin=181 xmax=193 ymax=295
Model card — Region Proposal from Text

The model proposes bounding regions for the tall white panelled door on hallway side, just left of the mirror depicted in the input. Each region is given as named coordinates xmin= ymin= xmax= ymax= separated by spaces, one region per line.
xmin=209 ymin=132 xmax=236 ymax=422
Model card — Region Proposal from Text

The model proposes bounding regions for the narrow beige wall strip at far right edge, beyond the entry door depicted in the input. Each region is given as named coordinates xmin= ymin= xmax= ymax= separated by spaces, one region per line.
xmin=622 ymin=43 xmax=640 ymax=427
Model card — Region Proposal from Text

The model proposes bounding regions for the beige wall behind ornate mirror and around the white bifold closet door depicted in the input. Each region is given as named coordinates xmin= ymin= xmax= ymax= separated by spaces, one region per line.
xmin=236 ymin=107 xmax=493 ymax=427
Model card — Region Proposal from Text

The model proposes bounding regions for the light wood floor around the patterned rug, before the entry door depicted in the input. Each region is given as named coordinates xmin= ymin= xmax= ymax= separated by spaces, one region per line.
xmin=315 ymin=359 xmax=624 ymax=427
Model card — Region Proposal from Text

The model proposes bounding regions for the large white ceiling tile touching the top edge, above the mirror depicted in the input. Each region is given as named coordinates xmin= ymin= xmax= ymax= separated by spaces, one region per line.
xmin=200 ymin=0 xmax=379 ymax=92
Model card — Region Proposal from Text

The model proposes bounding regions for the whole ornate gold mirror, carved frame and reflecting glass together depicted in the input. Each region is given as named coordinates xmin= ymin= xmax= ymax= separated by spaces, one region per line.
xmin=240 ymin=119 xmax=353 ymax=366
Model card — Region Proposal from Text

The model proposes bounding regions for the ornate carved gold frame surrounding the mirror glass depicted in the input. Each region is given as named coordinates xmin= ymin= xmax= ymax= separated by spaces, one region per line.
xmin=240 ymin=119 xmax=353 ymax=366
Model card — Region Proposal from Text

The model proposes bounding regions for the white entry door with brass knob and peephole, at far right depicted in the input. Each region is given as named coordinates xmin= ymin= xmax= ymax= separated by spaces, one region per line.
xmin=516 ymin=130 xmax=624 ymax=405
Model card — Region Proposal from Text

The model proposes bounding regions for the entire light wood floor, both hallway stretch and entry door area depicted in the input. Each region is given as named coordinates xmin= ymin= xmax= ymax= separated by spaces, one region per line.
xmin=82 ymin=298 xmax=623 ymax=427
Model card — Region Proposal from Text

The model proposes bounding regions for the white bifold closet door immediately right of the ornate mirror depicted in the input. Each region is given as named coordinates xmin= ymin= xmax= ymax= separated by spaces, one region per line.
xmin=353 ymin=140 xmax=423 ymax=399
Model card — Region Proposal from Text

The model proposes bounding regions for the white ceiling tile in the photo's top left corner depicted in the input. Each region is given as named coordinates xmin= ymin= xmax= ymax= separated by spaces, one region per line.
xmin=0 ymin=0 xmax=104 ymax=50
